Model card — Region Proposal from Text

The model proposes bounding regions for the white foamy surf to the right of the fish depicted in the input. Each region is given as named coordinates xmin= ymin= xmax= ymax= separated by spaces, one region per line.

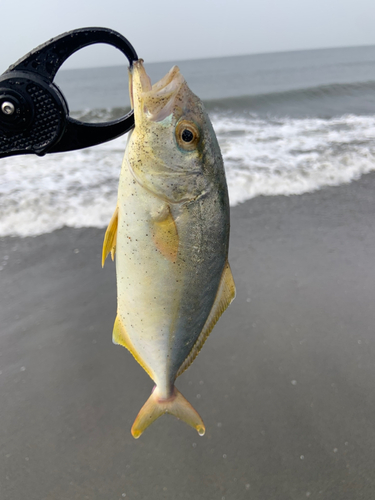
xmin=213 ymin=115 xmax=375 ymax=205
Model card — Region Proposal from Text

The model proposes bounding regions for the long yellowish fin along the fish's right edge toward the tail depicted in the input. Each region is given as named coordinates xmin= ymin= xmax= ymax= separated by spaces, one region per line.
xmin=177 ymin=262 xmax=236 ymax=377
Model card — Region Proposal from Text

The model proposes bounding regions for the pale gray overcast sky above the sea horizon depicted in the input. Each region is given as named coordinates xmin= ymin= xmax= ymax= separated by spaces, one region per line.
xmin=0 ymin=0 xmax=375 ymax=73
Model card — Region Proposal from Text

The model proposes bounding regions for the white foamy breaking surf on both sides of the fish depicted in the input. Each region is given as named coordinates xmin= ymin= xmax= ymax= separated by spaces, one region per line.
xmin=0 ymin=111 xmax=375 ymax=236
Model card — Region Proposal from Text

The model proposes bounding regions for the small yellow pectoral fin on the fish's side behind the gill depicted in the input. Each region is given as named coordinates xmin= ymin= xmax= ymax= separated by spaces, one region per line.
xmin=152 ymin=206 xmax=179 ymax=262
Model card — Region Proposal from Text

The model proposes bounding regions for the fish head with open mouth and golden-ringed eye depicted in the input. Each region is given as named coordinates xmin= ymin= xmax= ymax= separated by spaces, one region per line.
xmin=126 ymin=60 xmax=226 ymax=203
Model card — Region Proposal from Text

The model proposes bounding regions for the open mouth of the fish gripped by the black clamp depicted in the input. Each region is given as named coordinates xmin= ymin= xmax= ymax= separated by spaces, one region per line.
xmin=129 ymin=59 xmax=185 ymax=126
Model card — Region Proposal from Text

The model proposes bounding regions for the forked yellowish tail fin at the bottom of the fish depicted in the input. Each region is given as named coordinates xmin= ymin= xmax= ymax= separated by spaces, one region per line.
xmin=131 ymin=387 xmax=206 ymax=439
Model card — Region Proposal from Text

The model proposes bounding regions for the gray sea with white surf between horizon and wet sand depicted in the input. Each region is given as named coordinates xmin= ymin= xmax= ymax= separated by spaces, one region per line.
xmin=0 ymin=46 xmax=375 ymax=236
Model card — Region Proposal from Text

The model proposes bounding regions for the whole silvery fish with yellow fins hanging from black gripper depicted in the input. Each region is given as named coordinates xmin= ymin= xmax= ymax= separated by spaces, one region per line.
xmin=102 ymin=59 xmax=236 ymax=438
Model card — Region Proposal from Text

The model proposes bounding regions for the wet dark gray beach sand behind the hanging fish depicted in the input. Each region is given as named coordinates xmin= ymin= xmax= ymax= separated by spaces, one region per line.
xmin=0 ymin=174 xmax=375 ymax=500
